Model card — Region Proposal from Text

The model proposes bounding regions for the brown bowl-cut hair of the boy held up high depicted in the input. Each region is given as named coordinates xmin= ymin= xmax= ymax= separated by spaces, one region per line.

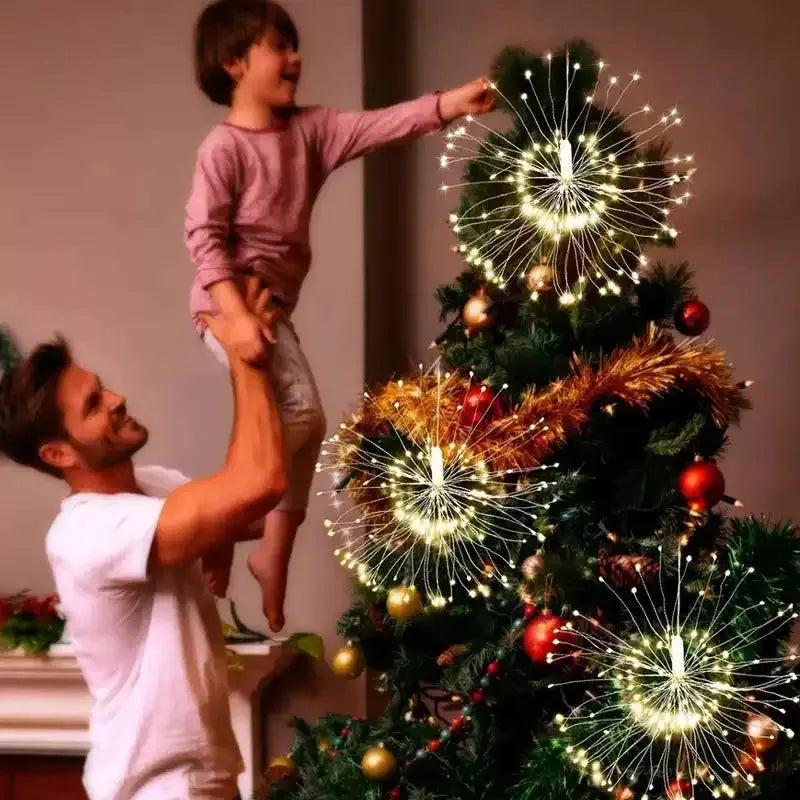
xmin=194 ymin=0 xmax=300 ymax=106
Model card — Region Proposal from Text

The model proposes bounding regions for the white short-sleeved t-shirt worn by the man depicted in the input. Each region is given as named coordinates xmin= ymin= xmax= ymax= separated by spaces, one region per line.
xmin=46 ymin=467 xmax=243 ymax=800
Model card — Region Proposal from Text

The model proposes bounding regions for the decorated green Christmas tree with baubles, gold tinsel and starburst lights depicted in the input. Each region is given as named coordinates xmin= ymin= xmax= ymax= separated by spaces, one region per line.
xmin=267 ymin=42 xmax=800 ymax=800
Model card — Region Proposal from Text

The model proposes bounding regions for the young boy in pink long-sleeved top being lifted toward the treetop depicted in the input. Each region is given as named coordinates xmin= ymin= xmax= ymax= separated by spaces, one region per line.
xmin=185 ymin=0 xmax=494 ymax=631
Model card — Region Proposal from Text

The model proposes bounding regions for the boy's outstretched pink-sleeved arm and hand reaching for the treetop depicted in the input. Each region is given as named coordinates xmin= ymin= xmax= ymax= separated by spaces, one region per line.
xmin=320 ymin=78 xmax=494 ymax=172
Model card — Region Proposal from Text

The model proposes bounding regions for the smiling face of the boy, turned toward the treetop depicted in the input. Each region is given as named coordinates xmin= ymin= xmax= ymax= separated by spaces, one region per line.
xmin=240 ymin=28 xmax=302 ymax=108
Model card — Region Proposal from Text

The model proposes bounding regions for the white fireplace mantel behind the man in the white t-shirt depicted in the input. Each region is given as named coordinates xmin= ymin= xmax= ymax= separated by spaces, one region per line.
xmin=0 ymin=641 xmax=293 ymax=797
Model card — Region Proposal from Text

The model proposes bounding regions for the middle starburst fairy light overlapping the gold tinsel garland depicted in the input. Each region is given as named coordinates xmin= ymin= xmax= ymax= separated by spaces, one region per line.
xmin=317 ymin=363 xmax=557 ymax=607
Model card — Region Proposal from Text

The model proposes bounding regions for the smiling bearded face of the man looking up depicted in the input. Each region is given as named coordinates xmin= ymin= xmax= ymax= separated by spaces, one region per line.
xmin=52 ymin=364 xmax=148 ymax=470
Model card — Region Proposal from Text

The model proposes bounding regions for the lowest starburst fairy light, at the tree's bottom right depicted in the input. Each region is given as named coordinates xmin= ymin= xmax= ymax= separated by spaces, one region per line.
xmin=548 ymin=555 xmax=798 ymax=800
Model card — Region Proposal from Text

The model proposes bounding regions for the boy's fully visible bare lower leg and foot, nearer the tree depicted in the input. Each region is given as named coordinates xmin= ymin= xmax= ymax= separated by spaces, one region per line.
xmin=247 ymin=509 xmax=306 ymax=633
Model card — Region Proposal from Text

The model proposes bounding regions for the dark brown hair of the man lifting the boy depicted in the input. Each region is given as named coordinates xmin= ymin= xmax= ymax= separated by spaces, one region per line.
xmin=0 ymin=336 xmax=72 ymax=478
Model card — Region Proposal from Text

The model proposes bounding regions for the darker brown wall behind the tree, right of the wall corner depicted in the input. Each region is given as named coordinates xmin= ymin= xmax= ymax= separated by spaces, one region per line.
xmin=365 ymin=0 xmax=800 ymax=521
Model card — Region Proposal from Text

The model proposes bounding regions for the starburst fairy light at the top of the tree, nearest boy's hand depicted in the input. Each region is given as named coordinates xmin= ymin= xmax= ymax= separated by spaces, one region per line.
xmin=440 ymin=45 xmax=694 ymax=304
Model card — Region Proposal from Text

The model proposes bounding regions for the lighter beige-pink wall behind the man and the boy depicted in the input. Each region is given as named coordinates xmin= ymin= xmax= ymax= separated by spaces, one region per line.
xmin=0 ymin=0 xmax=363 ymax=749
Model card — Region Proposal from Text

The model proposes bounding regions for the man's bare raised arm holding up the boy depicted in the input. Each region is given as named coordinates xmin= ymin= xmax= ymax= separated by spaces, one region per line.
xmin=148 ymin=282 xmax=286 ymax=569
